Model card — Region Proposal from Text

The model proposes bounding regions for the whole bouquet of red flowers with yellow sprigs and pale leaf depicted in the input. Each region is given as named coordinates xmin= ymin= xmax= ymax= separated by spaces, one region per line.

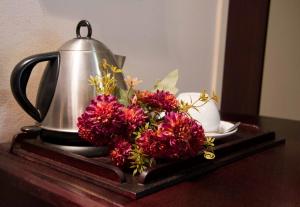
xmin=77 ymin=59 xmax=216 ymax=175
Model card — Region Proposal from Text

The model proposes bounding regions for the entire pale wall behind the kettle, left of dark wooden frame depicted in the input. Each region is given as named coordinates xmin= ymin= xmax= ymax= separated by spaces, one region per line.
xmin=0 ymin=0 xmax=228 ymax=142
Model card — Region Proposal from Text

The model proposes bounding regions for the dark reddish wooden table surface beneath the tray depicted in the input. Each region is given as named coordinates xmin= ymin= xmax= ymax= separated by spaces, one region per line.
xmin=0 ymin=115 xmax=300 ymax=207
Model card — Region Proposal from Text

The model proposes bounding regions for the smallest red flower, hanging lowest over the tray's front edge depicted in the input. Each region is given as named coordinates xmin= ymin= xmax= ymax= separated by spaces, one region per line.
xmin=110 ymin=138 xmax=132 ymax=168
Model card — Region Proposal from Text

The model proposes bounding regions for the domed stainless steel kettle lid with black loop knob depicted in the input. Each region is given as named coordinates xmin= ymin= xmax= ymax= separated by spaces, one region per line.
xmin=59 ymin=20 xmax=110 ymax=52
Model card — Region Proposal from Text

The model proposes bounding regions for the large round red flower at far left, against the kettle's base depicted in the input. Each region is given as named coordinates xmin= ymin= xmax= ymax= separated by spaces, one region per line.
xmin=77 ymin=95 xmax=124 ymax=146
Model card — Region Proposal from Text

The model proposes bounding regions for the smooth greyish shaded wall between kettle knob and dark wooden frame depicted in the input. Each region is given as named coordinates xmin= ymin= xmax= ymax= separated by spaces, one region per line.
xmin=39 ymin=0 xmax=218 ymax=91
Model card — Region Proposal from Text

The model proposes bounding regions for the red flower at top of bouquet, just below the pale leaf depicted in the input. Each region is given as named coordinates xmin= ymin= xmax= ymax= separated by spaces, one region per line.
xmin=137 ymin=90 xmax=178 ymax=112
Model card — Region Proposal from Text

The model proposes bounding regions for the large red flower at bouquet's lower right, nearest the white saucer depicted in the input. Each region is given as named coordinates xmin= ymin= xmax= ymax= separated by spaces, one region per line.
xmin=136 ymin=112 xmax=205 ymax=159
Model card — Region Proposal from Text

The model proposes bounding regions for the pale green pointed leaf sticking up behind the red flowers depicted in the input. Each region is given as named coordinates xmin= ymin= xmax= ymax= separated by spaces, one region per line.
xmin=153 ymin=69 xmax=178 ymax=94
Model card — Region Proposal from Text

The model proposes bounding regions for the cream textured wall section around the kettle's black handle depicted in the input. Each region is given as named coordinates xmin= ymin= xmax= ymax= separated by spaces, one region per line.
xmin=0 ymin=0 xmax=64 ymax=142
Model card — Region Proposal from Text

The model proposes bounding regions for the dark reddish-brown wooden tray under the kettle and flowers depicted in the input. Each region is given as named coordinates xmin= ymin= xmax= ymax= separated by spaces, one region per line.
xmin=11 ymin=123 xmax=285 ymax=199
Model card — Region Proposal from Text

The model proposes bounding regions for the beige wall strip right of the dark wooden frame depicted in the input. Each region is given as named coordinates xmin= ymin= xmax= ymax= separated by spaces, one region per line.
xmin=260 ymin=0 xmax=300 ymax=120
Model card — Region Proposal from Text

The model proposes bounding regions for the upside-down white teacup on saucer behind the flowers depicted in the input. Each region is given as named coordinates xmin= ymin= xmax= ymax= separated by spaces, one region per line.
xmin=177 ymin=92 xmax=220 ymax=132
